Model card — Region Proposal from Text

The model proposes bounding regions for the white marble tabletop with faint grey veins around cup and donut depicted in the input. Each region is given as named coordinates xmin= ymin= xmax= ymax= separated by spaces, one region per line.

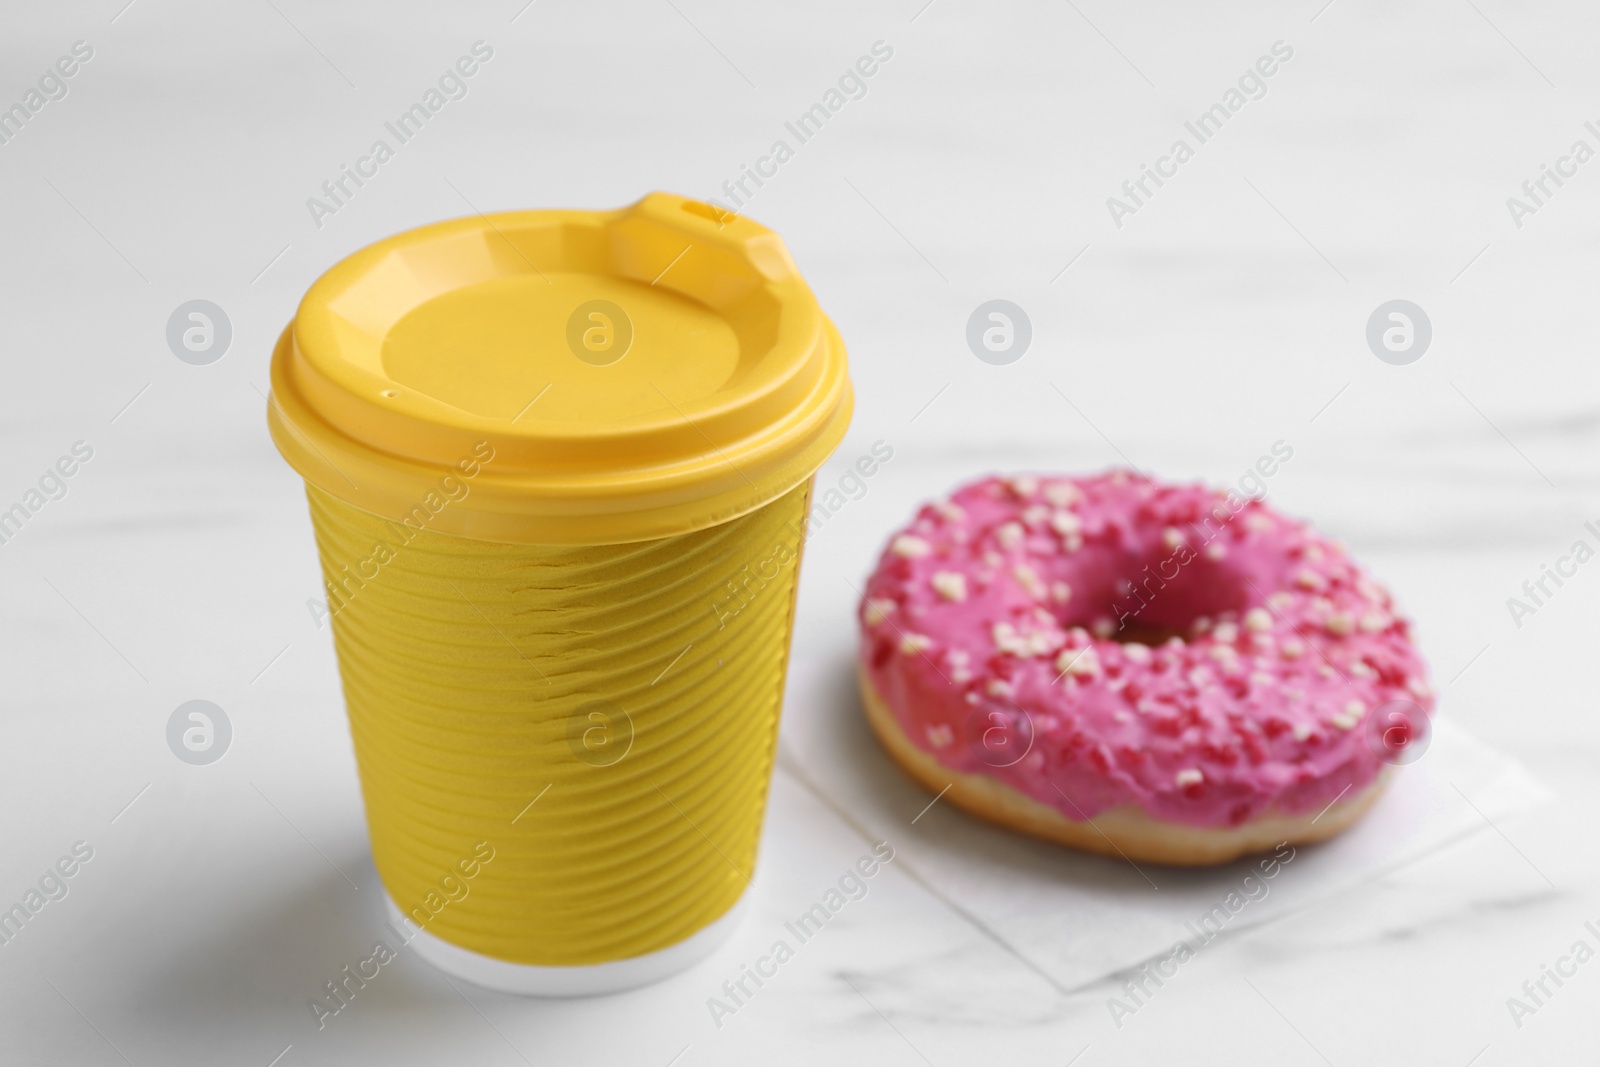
xmin=0 ymin=0 xmax=1600 ymax=1067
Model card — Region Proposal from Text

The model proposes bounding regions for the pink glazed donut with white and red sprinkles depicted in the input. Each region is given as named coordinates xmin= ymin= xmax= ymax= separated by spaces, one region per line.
xmin=861 ymin=470 xmax=1434 ymax=865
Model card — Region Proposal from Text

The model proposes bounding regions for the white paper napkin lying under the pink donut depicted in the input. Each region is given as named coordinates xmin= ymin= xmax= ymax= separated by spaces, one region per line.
xmin=779 ymin=639 xmax=1552 ymax=992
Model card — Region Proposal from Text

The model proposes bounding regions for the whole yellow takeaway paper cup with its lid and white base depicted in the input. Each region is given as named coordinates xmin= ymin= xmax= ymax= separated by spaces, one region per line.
xmin=267 ymin=194 xmax=851 ymax=995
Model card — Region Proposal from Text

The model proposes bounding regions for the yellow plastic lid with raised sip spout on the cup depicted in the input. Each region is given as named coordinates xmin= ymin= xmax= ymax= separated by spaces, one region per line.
xmin=267 ymin=192 xmax=853 ymax=544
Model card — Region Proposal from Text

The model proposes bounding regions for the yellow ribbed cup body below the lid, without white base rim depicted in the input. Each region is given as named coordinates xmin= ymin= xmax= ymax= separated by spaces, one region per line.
xmin=307 ymin=485 xmax=810 ymax=966
